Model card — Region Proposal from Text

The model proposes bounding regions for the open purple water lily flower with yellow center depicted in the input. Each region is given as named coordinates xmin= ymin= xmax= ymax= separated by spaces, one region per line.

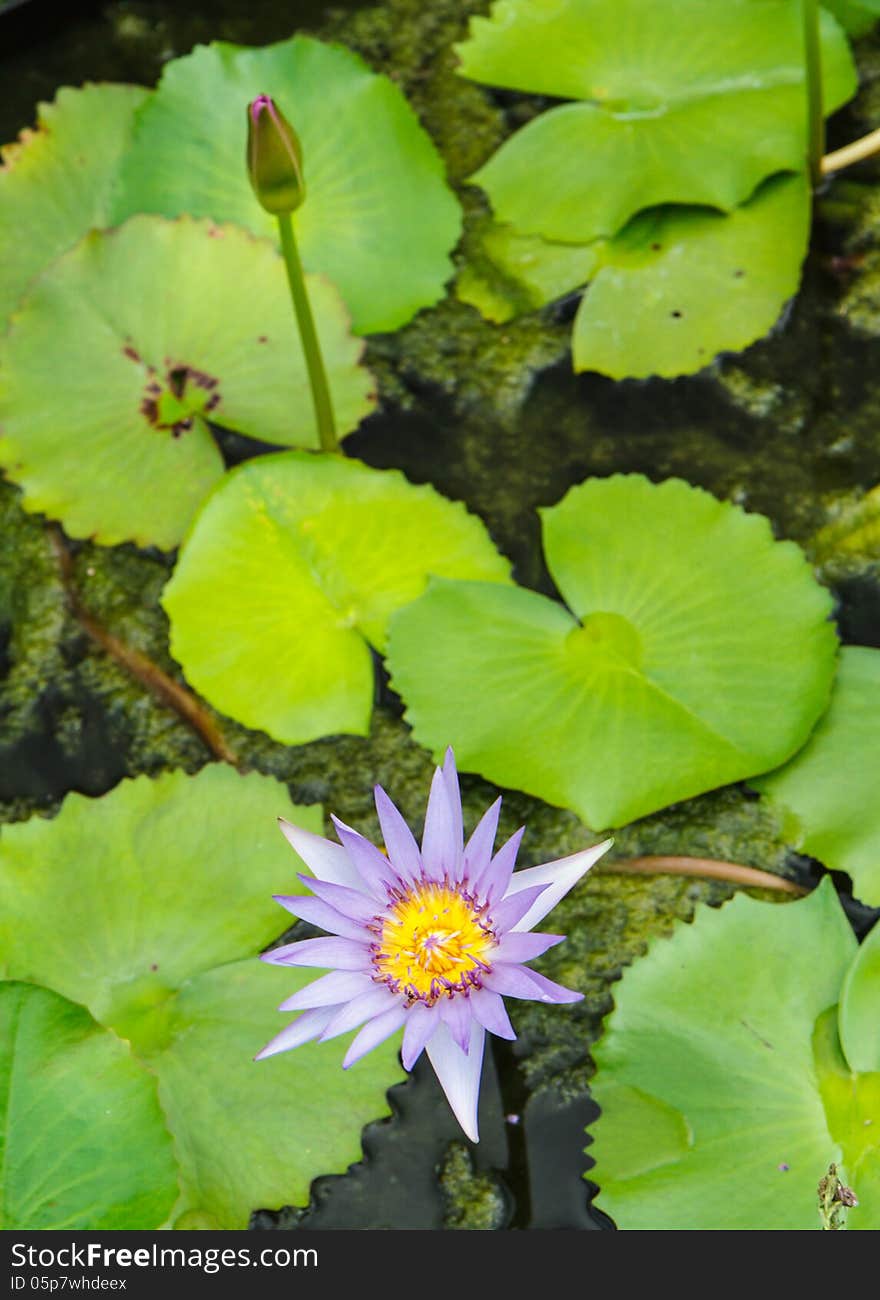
xmin=256 ymin=749 xmax=611 ymax=1141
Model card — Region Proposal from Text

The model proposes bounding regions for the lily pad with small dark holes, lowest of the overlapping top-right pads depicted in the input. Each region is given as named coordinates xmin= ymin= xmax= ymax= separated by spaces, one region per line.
xmin=456 ymin=176 xmax=810 ymax=378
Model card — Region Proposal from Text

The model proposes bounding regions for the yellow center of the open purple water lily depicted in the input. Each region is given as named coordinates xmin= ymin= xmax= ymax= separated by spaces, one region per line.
xmin=373 ymin=881 xmax=495 ymax=1006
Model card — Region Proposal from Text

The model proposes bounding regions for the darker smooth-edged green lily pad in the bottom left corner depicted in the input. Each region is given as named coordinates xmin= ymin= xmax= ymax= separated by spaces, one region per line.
xmin=0 ymin=983 xmax=178 ymax=1231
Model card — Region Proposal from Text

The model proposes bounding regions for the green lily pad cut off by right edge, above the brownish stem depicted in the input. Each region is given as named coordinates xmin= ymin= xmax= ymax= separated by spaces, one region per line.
xmin=750 ymin=646 xmax=880 ymax=906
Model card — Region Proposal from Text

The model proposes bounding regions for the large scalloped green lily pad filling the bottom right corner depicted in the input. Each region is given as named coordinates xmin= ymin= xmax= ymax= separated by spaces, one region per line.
xmin=589 ymin=880 xmax=880 ymax=1230
